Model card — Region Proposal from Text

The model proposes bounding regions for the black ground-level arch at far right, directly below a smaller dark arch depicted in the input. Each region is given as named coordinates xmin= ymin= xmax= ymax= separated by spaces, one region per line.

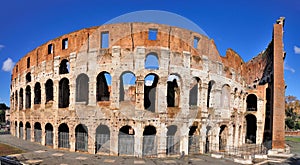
xmin=246 ymin=114 xmax=257 ymax=144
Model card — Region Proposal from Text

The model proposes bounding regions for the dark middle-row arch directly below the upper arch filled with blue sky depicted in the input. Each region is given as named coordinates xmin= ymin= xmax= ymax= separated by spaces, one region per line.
xmin=144 ymin=73 xmax=158 ymax=112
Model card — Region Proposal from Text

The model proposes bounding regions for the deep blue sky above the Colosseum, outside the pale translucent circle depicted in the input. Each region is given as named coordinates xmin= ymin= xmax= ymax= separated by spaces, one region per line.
xmin=0 ymin=0 xmax=300 ymax=105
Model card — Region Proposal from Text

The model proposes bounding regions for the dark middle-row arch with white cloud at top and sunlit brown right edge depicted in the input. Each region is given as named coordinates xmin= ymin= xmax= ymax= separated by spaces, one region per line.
xmin=167 ymin=74 xmax=180 ymax=107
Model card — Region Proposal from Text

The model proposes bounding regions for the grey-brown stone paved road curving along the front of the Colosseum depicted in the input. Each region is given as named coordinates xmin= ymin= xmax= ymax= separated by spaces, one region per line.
xmin=0 ymin=135 xmax=236 ymax=165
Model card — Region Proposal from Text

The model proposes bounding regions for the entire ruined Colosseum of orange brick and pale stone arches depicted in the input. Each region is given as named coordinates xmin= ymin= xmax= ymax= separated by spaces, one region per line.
xmin=10 ymin=17 xmax=285 ymax=157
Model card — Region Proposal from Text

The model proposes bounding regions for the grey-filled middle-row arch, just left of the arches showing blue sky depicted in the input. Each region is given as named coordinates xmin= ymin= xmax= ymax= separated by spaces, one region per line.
xmin=76 ymin=73 xmax=89 ymax=104
